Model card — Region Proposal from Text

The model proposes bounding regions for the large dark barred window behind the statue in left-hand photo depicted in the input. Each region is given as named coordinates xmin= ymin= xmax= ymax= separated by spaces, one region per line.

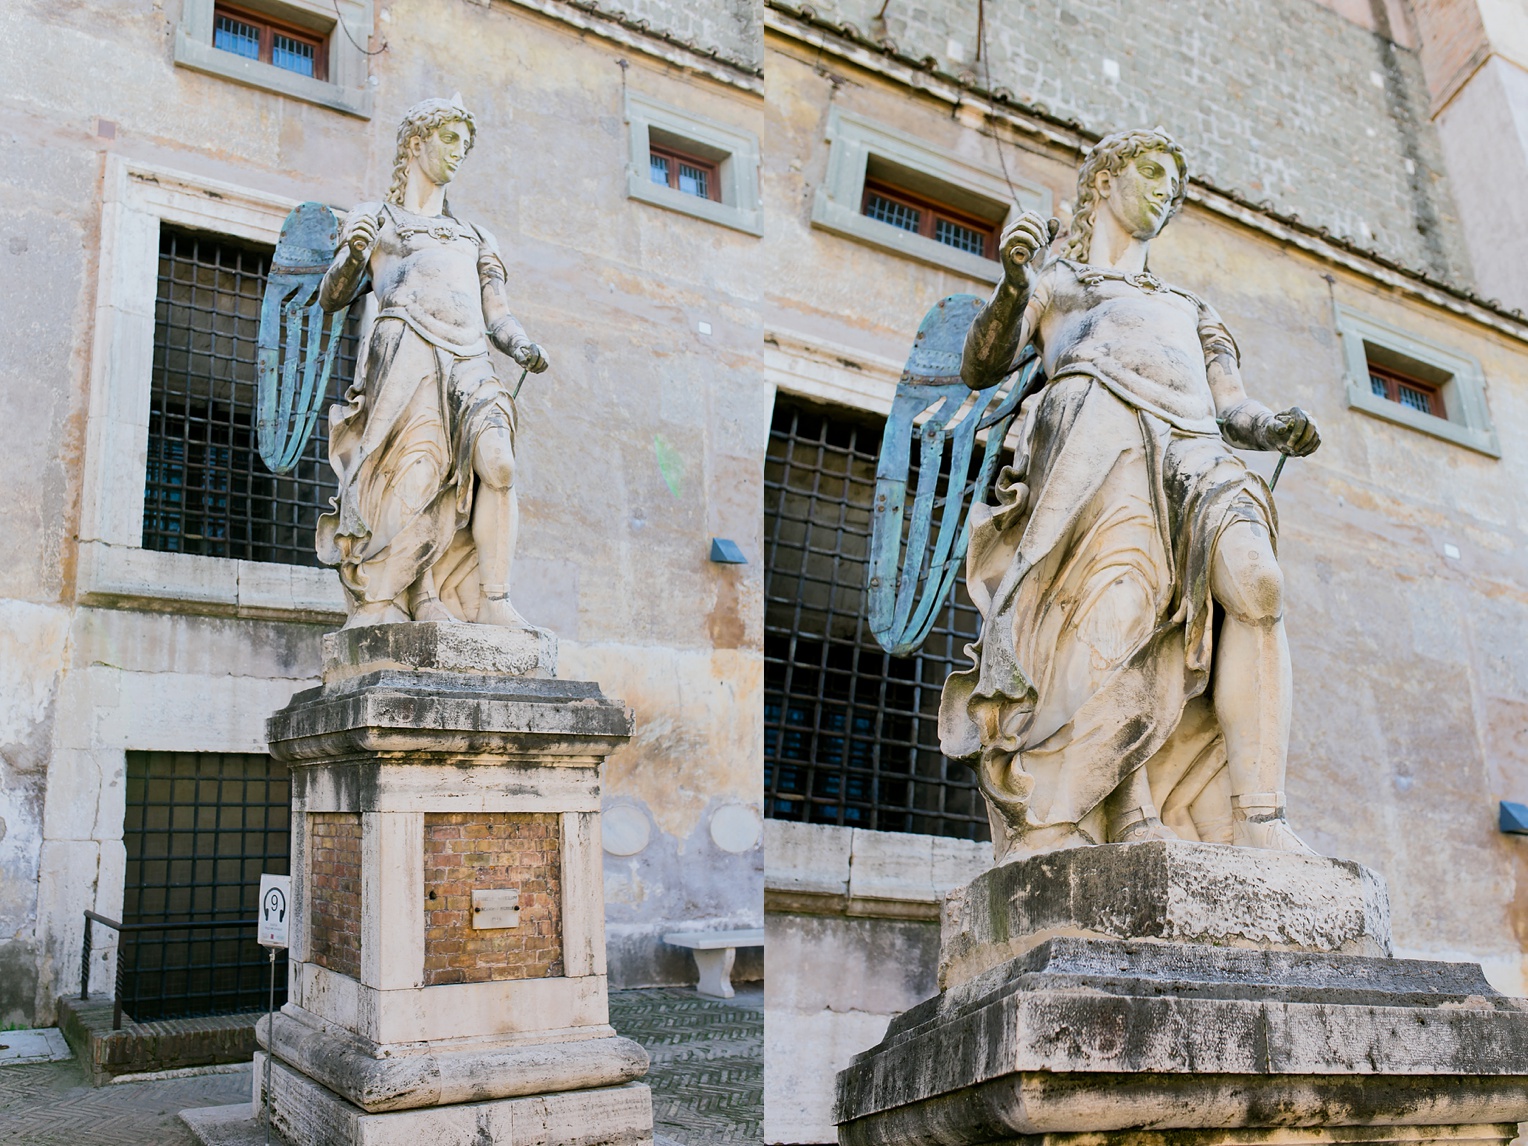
xmin=144 ymin=225 xmax=356 ymax=565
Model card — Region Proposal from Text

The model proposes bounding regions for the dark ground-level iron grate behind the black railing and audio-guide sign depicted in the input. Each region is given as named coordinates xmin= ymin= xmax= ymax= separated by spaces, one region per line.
xmin=119 ymin=752 xmax=292 ymax=1022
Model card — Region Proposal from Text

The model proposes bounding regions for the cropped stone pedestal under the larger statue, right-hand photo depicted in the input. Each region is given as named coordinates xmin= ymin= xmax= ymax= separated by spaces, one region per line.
xmin=837 ymin=842 xmax=1528 ymax=1146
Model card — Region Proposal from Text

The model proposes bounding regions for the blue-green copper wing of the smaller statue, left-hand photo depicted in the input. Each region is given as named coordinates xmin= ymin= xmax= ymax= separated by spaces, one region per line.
xmin=255 ymin=203 xmax=350 ymax=474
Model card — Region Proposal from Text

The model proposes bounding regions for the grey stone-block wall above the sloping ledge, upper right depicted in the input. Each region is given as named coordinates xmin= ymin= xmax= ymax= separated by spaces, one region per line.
xmin=782 ymin=0 xmax=1470 ymax=284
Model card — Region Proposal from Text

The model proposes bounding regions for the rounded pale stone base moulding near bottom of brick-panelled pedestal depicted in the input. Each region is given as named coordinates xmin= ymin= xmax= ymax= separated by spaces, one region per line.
xmin=255 ymin=1010 xmax=648 ymax=1114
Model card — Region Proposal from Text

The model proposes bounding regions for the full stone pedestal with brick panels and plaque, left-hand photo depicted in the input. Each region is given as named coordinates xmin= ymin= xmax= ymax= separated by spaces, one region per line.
xmin=255 ymin=623 xmax=652 ymax=1146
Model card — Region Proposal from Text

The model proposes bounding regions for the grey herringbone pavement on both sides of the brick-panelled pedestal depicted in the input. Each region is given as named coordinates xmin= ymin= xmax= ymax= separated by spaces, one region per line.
xmin=0 ymin=984 xmax=764 ymax=1146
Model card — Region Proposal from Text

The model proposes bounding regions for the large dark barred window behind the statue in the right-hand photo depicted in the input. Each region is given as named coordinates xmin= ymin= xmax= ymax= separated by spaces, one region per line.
xmin=764 ymin=396 xmax=989 ymax=840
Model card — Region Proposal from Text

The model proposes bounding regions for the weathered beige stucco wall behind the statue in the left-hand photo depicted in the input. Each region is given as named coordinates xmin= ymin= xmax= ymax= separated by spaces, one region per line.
xmin=0 ymin=0 xmax=769 ymax=1022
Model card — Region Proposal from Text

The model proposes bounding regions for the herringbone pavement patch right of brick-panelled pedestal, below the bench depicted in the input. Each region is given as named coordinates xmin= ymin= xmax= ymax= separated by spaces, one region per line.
xmin=610 ymin=984 xmax=764 ymax=1146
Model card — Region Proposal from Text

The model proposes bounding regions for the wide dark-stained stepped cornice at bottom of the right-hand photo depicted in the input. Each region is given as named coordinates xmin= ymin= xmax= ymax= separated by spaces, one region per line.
xmin=837 ymin=938 xmax=1528 ymax=1146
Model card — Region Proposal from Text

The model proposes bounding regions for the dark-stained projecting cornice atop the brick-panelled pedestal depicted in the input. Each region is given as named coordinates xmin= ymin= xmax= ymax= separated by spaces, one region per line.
xmin=266 ymin=671 xmax=633 ymax=767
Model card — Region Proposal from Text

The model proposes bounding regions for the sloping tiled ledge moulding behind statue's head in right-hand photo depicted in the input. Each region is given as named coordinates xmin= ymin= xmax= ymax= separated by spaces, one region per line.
xmin=764 ymin=0 xmax=1528 ymax=342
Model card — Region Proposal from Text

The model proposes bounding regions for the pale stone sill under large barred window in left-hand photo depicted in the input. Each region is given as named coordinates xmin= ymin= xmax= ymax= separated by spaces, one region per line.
xmin=78 ymin=541 xmax=345 ymax=623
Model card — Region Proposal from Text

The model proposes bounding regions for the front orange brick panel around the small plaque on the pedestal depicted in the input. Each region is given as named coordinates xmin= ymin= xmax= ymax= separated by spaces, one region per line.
xmin=425 ymin=811 xmax=562 ymax=987
